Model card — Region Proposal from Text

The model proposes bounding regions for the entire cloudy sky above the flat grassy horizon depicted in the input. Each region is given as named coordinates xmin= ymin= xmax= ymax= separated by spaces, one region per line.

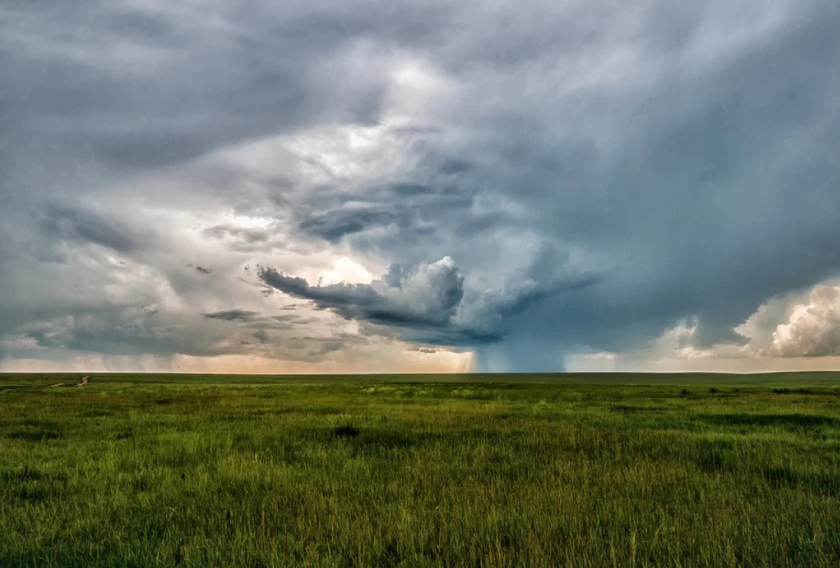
xmin=0 ymin=0 xmax=840 ymax=373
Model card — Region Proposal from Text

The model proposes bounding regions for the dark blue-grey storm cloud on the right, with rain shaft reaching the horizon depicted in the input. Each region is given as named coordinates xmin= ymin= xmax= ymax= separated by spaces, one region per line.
xmin=272 ymin=2 xmax=840 ymax=368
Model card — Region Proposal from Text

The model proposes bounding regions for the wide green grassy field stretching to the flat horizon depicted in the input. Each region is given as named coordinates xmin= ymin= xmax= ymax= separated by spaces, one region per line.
xmin=0 ymin=373 xmax=840 ymax=568
